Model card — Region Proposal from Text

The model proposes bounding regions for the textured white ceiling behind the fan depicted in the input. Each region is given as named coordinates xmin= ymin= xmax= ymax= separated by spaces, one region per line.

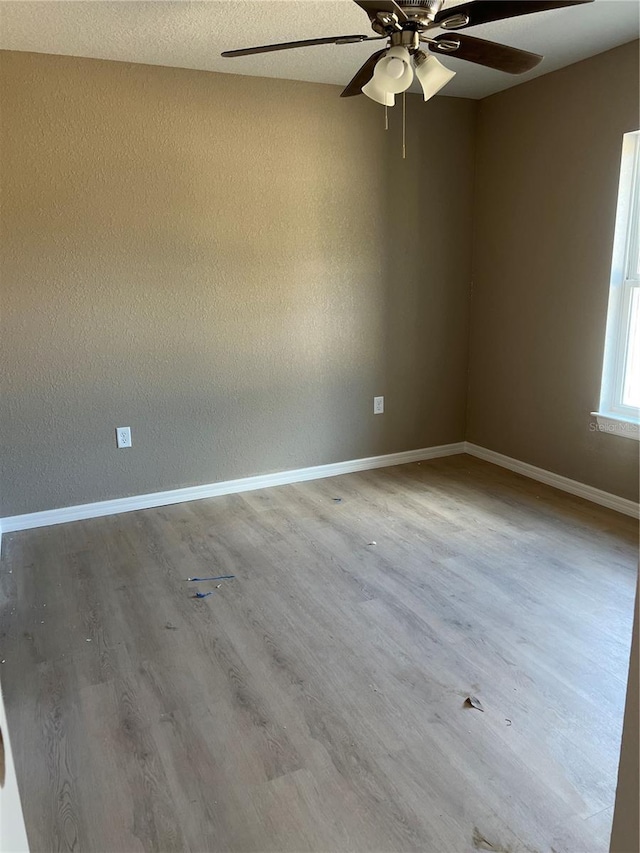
xmin=0 ymin=0 xmax=640 ymax=98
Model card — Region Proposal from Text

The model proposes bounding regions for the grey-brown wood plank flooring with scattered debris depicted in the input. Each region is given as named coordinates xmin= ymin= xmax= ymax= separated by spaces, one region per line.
xmin=0 ymin=456 xmax=638 ymax=853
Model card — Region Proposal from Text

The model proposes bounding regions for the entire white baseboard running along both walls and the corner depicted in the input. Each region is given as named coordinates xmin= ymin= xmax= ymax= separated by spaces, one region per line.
xmin=0 ymin=441 xmax=640 ymax=548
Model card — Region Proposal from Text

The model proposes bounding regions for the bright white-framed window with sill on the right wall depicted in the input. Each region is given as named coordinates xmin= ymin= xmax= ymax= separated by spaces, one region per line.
xmin=593 ymin=131 xmax=640 ymax=446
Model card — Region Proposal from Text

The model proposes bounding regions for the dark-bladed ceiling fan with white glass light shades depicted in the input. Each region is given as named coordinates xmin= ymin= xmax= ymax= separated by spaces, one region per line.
xmin=222 ymin=0 xmax=593 ymax=107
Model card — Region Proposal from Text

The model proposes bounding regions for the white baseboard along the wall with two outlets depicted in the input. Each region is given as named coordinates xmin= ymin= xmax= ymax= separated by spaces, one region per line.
xmin=0 ymin=441 xmax=464 ymax=533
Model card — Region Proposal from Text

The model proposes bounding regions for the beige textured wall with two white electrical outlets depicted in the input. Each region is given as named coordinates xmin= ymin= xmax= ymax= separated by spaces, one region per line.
xmin=0 ymin=52 xmax=476 ymax=516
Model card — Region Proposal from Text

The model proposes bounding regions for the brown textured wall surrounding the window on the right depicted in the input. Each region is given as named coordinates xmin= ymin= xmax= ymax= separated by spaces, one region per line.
xmin=467 ymin=42 xmax=640 ymax=500
